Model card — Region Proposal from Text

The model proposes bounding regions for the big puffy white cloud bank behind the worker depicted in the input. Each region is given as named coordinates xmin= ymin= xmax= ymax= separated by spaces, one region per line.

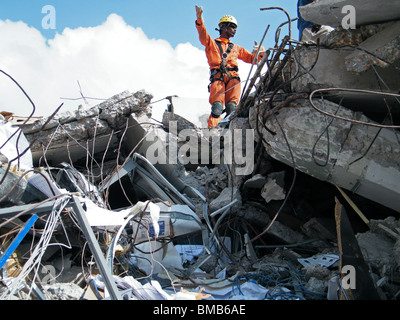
xmin=0 ymin=14 xmax=253 ymax=122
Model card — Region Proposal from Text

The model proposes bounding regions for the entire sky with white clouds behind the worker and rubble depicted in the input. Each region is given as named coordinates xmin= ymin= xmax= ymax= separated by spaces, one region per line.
xmin=0 ymin=0 xmax=298 ymax=120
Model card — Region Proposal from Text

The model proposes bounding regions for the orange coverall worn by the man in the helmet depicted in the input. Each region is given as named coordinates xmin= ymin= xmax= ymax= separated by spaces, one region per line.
xmin=196 ymin=20 xmax=262 ymax=127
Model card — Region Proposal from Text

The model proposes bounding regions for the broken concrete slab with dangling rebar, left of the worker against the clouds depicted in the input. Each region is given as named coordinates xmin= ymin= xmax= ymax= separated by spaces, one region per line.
xmin=18 ymin=91 xmax=152 ymax=165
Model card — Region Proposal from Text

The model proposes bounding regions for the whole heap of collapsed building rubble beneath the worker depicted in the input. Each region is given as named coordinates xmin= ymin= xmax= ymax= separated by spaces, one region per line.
xmin=0 ymin=3 xmax=400 ymax=300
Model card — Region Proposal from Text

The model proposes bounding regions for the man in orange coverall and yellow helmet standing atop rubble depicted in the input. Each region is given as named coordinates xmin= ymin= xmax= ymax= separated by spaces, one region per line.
xmin=196 ymin=6 xmax=265 ymax=128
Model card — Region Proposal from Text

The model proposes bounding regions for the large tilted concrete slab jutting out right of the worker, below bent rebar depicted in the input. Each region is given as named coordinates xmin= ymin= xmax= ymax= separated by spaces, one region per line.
xmin=249 ymin=100 xmax=400 ymax=211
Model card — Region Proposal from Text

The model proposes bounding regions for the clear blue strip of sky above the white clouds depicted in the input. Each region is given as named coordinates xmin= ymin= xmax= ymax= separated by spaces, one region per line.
xmin=0 ymin=0 xmax=297 ymax=50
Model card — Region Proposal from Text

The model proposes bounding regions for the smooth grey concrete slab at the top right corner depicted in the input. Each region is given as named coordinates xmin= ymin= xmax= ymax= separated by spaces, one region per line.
xmin=299 ymin=0 xmax=400 ymax=27
